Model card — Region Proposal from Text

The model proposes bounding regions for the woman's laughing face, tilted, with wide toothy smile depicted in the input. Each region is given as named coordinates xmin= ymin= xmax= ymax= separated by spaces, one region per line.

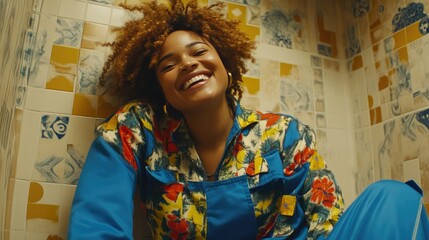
xmin=156 ymin=30 xmax=228 ymax=114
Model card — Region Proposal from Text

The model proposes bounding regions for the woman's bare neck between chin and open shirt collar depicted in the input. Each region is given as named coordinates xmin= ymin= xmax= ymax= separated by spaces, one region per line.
xmin=184 ymin=99 xmax=234 ymax=146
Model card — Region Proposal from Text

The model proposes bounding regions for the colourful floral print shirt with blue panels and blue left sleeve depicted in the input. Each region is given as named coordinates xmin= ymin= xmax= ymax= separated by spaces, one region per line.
xmin=69 ymin=101 xmax=344 ymax=239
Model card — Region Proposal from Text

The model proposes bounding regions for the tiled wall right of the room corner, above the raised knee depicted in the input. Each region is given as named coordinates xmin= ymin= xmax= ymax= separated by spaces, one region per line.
xmin=344 ymin=0 xmax=429 ymax=204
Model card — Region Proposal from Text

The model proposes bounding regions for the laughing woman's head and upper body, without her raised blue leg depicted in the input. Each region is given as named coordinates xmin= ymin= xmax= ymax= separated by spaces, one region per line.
xmin=69 ymin=0 xmax=426 ymax=239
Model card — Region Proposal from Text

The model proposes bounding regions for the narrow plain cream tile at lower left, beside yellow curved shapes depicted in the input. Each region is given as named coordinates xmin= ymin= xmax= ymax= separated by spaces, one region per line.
xmin=10 ymin=180 xmax=30 ymax=231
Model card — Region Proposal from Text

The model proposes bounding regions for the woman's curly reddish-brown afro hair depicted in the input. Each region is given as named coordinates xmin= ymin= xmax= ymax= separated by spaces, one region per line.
xmin=100 ymin=0 xmax=255 ymax=117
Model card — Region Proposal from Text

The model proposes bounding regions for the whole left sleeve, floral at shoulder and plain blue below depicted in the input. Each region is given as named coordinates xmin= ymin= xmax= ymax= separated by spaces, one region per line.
xmin=68 ymin=102 xmax=145 ymax=240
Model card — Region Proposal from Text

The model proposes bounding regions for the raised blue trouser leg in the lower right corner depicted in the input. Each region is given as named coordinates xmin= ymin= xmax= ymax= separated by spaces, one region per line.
xmin=328 ymin=180 xmax=429 ymax=240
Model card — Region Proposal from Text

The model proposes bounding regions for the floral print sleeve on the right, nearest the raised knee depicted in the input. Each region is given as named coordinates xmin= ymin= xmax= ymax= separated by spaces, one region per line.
xmin=284 ymin=119 xmax=344 ymax=240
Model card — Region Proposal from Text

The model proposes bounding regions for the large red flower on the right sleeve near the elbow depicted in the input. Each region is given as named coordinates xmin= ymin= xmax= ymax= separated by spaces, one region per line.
xmin=310 ymin=177 xmax=336 ymax=208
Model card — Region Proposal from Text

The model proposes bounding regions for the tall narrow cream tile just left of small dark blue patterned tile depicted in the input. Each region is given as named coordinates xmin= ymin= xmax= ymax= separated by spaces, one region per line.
xmin=16 ymin=110 xmax=40 ymax=180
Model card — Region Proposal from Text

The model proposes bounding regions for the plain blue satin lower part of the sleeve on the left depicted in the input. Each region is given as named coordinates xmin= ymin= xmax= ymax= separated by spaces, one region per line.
xmin=68 ymin=137 xmax=136 ymax=240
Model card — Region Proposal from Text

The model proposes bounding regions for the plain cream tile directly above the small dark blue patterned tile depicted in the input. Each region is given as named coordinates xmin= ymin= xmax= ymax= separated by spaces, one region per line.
xmin=43 ymin=90 xmax=74 ymax=114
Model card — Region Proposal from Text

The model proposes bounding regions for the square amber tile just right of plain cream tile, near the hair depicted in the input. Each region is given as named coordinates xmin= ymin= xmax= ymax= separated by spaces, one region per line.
xmin=72 ymin=94 xmax=98 ymax=117
